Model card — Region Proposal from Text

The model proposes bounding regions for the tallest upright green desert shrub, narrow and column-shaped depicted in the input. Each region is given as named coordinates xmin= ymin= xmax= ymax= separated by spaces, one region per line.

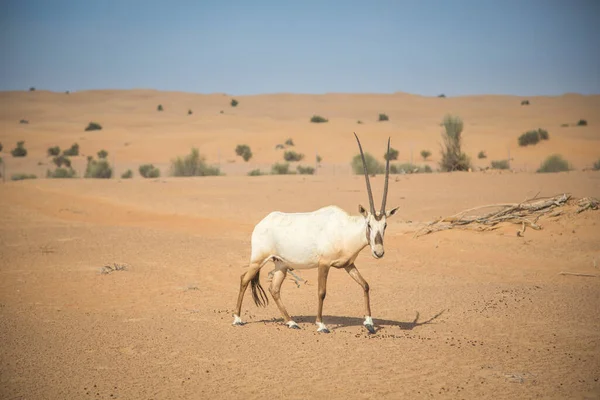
xmin=440 ymin=115 xmax=471 ymax=171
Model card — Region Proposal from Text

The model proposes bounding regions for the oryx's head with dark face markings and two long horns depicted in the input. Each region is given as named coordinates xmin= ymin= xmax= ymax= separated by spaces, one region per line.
xmin=354 ymin=132 xmax=398 ymax=258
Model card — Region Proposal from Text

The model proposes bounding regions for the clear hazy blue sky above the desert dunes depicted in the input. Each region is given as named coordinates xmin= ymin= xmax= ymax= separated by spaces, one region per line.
xmin=0 ymin=0 xmax=600 ymax=96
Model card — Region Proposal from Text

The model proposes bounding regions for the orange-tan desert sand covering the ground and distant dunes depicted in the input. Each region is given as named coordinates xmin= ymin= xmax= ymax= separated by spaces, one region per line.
xmin=0 ymin=90 xmax=600 ymax=399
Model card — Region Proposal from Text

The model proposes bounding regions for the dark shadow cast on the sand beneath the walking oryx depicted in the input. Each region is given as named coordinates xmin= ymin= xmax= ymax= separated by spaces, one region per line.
xmin=257 ymin=309 xmax=447 ymax=332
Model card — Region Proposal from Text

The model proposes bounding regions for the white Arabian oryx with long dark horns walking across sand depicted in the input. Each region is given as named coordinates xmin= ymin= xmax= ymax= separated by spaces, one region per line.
xmin=233 ymin=133 xmax=398 ymax=333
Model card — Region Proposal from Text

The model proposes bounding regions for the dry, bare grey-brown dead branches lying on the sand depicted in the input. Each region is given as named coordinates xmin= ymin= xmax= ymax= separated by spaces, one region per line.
xmin=415 ymin=193 xmax=600 ymax=237
